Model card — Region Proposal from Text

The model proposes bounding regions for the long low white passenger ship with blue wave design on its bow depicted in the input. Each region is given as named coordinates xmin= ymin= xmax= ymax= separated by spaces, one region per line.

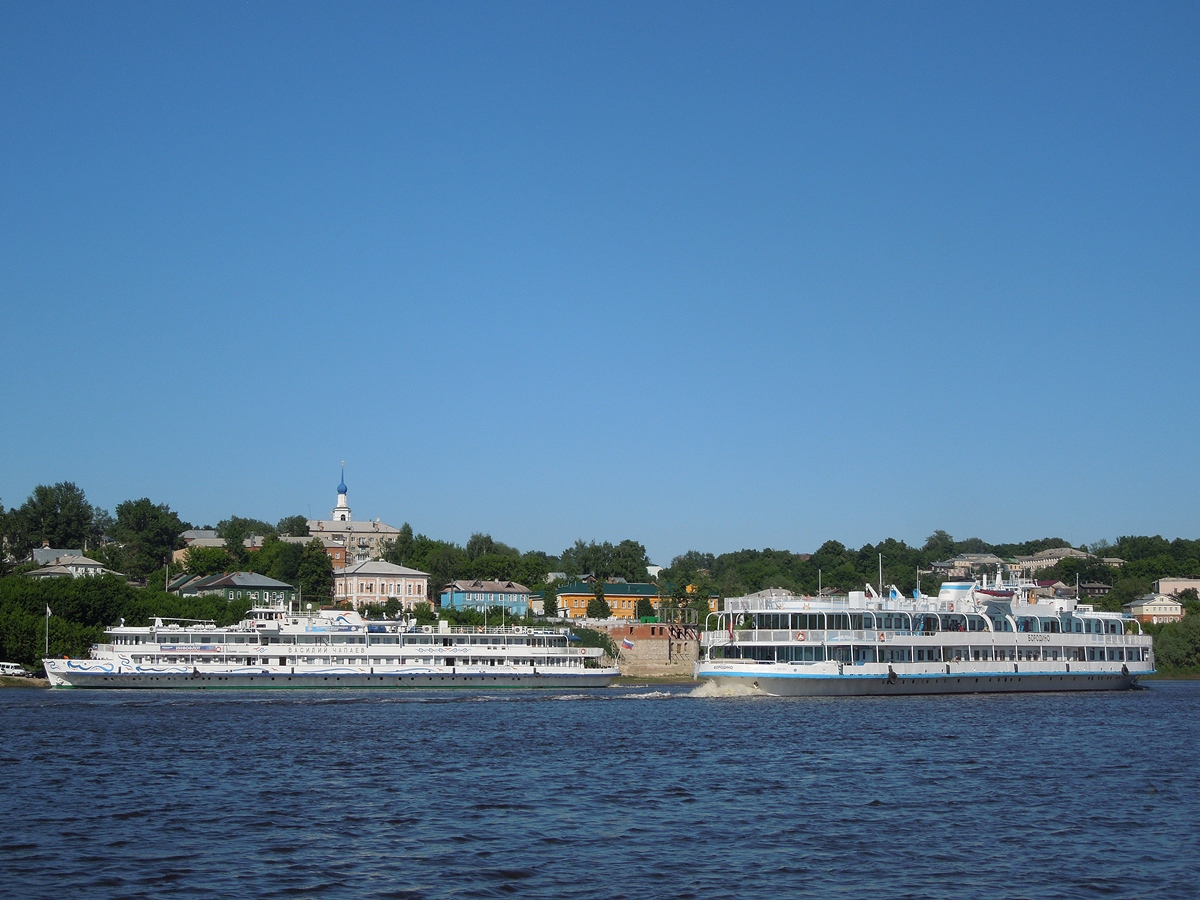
xmin=46 ymin=606 xmax=620 ymax=689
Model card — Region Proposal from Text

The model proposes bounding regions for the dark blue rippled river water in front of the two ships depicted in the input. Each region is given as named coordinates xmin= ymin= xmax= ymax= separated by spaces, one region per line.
xmin=0 ymin=682 xmax=1200 ymax=898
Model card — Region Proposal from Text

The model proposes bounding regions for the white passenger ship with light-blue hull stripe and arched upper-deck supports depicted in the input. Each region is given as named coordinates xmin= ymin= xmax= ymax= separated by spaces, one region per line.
xmin=696 ymin=578 xmax=1154 ymax=696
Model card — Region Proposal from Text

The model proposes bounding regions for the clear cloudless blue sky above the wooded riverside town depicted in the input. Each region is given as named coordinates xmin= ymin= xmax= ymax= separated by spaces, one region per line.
xmin=0 ymin=2 xmax=1200 ymax=563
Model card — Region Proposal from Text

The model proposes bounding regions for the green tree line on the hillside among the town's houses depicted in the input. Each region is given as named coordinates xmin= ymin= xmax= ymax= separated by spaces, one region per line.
xmin=0 ymin=482 xmax=1200 ymax=668
